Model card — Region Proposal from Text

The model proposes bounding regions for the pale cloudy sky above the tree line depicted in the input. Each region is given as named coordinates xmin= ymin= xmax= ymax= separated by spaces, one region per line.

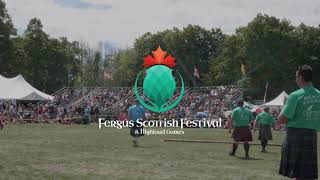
xmin=5 ymin=0 xmax=320 ymax=47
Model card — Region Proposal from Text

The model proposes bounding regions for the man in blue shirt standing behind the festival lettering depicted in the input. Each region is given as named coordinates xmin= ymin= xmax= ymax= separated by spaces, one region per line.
xmin=128 ymin=100 xmax=146 ymax=147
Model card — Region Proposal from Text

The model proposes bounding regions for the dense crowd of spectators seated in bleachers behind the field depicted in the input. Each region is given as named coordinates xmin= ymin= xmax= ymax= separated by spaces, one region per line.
xmin=0 ymin=86 xmax=241 ymax=124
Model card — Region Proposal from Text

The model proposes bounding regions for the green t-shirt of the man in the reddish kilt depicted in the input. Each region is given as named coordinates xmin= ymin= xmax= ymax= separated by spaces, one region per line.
xmin=231 ymin=107 xmax=253 ymax=127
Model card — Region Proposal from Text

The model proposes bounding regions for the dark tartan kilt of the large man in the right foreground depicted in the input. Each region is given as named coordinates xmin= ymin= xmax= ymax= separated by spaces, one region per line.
xmin=279 ymin=128 xmax=318 ymax=179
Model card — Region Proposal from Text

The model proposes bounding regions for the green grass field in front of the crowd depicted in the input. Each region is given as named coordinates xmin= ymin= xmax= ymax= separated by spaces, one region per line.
xmin=0 ymin=124 xmax=318 ymax=180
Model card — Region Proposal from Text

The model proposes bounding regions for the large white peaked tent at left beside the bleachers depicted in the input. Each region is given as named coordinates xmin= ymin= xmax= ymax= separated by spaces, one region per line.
xmin=0 ymin=75 xmax=53 ymax=100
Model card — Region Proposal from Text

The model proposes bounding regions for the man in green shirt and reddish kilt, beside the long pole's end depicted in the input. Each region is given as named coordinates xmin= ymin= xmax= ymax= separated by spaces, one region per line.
xmin=229 ymin=100 xmax=254 ymax=159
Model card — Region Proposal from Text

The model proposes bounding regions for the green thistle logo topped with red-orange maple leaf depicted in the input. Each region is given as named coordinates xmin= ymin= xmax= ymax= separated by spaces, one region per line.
xmin=134 ymin=46 xmax=185 ymax=112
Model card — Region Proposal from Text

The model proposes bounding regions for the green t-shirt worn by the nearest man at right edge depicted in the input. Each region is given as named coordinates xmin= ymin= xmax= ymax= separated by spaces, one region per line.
xmin=282 ymin=86 xmax=320 ymax=130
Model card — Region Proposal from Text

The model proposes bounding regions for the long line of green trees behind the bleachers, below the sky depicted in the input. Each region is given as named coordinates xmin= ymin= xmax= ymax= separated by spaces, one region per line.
xmin=0 ymin=0 xmax=320 ymax=100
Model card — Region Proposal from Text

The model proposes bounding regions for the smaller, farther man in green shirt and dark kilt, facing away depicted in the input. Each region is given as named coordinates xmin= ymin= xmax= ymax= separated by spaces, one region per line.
xmin=254 ymin=107 xmax=275 ymax=153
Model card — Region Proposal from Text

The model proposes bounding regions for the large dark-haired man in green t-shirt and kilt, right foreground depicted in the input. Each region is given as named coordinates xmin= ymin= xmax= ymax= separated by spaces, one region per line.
xmin=278 ymin=65 xmax=320 ymax=179
